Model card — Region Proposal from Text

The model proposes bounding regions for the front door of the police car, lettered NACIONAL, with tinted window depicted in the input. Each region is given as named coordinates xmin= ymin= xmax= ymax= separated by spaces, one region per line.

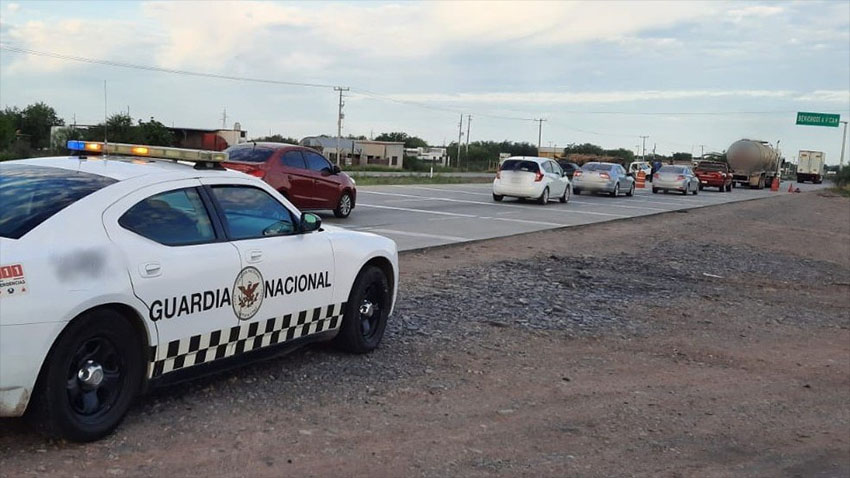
xmin=202 ymin=178 xmax=342 ymax=350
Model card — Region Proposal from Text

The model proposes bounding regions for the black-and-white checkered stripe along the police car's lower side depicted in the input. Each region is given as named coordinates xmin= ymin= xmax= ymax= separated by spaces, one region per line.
xmin=148 ymin=303 xmax=345 ymax=378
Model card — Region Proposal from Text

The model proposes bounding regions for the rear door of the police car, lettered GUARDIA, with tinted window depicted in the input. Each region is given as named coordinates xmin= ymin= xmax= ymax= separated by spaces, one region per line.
xmin=103 ymin=179 xmax=241 ymax=377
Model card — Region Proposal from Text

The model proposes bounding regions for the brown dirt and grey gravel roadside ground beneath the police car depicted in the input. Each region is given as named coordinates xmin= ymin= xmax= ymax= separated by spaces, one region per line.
xmin=0 ymin=193 xmax=850 ymax=477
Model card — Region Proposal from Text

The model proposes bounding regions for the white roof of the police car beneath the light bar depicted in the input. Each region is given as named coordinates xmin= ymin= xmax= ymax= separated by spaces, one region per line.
xmin=8 ymin=155 xmax=244 ymax=181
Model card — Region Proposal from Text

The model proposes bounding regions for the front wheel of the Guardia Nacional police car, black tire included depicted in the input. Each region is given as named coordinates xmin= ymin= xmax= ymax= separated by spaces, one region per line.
xmin=334 ymin=266 xmax=390 ymax=354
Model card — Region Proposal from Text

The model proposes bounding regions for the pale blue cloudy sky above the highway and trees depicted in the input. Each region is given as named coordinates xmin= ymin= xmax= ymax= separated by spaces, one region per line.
xmin=0 ymin=0 xmax=850 ymax=163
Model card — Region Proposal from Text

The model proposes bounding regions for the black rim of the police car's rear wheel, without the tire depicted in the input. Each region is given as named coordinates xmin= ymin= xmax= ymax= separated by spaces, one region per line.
xmin=65 ymin=337 xmax=124 ymax=418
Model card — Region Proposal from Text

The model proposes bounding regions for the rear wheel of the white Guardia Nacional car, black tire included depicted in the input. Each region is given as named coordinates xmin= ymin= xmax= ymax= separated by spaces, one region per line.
xmin=27 ymin=309 xmax=145 ymax=442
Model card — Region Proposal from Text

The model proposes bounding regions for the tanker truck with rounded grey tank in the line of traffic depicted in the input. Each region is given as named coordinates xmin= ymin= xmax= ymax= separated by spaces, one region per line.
xmin=726 ymin=139 xmax=779 ymax=189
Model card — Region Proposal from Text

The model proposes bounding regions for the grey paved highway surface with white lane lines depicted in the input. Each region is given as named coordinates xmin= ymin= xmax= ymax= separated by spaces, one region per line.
xmin=322 ymin=182 xmax=826 ymax=251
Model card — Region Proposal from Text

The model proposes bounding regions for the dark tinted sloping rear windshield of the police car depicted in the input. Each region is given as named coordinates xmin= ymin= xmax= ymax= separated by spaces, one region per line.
xmin=0 ymin=164 xmax=116 ymax=239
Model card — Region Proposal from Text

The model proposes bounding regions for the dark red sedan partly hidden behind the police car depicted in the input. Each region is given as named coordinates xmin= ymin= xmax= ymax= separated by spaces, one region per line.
xmin=224 ymin=142 xmax=357 ymax=217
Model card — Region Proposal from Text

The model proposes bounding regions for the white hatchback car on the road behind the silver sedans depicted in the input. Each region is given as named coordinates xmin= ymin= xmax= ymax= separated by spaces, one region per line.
xmin=493 ymin=156 xmax=572 ymax=204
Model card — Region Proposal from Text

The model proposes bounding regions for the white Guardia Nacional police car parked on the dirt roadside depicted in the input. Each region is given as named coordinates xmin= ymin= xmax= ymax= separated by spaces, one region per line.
xmin=0 ymin=141 xmax=398 ymax=441
